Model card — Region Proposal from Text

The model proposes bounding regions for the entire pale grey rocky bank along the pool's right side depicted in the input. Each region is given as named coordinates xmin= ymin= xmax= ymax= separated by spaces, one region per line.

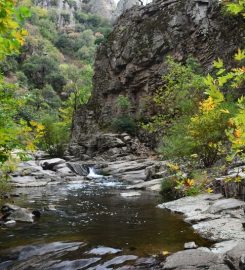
xmin=158 ymin=194 xmax=245 ymax=270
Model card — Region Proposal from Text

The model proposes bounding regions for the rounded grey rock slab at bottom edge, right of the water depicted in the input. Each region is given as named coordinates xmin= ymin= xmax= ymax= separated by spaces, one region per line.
xmin=163 ymin=250 xmax=230 ymax=270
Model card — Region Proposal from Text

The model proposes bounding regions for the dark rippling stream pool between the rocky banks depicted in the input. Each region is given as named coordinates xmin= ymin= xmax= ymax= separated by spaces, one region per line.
xmin=0 ymin=174 xmax=209 ymax=270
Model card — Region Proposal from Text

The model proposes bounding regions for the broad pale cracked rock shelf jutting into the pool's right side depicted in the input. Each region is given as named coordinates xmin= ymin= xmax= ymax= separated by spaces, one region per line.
xmin=158 ymin=194 xmax=245 ymax=244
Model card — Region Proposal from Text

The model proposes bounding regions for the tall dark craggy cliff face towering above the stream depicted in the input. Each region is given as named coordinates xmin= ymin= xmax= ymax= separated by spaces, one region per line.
xmin=72 ymin=0 xmax=244 ymax=160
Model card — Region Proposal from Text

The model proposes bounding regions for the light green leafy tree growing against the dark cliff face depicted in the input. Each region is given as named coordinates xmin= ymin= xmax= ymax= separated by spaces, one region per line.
xmin=143 ymin=57 xmax=206 ymax=134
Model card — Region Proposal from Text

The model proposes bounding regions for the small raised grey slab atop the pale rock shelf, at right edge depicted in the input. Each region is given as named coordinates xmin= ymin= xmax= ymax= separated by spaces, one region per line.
xmin=207 ymin=198 xmax=245 ymax=214
